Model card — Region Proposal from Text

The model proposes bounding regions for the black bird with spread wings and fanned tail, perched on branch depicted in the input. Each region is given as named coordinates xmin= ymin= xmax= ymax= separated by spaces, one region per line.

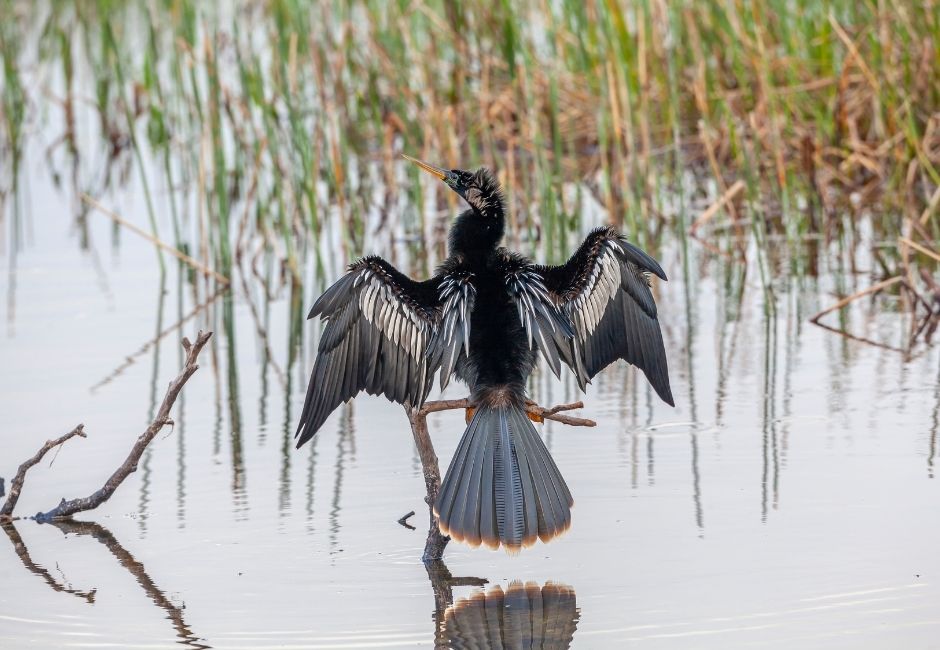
xmin=296 ymin=156 xmax=673 ymax=551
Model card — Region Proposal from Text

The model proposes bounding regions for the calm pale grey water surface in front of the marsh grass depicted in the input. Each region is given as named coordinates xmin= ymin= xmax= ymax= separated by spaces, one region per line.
xmin=0 ymin=148 xmax=940 ymax=648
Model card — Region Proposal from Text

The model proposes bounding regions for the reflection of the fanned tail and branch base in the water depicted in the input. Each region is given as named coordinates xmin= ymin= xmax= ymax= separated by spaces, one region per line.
xmin=428 ymin=562 xmax=580 ymax=650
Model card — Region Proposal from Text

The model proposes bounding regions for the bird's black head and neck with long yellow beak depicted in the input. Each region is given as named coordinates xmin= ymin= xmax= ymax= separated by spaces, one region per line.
xmin=402 ymin=154 xmax=505 ymax=252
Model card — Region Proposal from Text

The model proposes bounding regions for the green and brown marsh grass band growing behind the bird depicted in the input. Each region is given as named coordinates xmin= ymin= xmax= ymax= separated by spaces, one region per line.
xmin=0 ymin=0 xmax=940 ymax=342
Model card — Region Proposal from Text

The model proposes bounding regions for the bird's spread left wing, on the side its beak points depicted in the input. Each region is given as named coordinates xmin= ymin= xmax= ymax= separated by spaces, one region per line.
xmin=295 ymin=257 xmax=475 ymax=447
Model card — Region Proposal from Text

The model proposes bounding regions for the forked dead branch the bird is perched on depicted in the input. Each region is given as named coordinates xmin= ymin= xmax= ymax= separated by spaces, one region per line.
xmin=405 ymin=392 xmax=597 ymax=564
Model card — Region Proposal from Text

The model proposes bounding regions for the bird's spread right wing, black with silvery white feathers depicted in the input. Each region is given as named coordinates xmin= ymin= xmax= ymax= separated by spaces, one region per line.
xmin=535 ymin=227 xmax=674 ymax=405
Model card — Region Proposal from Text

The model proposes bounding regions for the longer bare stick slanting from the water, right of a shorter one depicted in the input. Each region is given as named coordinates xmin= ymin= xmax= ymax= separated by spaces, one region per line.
xmin=36 ymin=332 xmax=212 ymax=522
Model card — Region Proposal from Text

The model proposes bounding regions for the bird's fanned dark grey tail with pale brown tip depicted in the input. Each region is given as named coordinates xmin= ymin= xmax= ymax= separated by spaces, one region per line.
xmin=434 ymin=405 xmax=574 ymax=551
